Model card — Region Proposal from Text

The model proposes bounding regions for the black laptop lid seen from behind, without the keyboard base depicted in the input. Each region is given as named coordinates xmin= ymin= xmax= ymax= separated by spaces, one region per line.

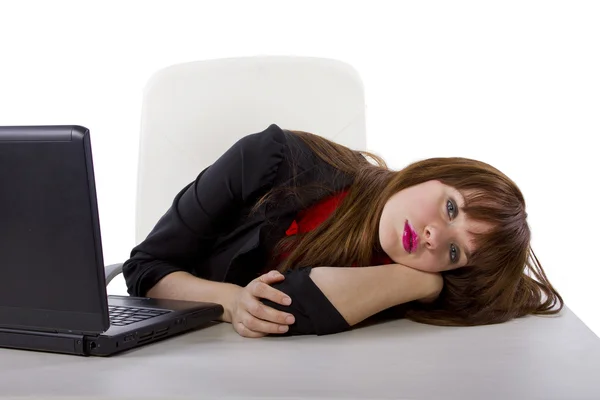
xmin=0 ymin=126 xmax=109 ymax=333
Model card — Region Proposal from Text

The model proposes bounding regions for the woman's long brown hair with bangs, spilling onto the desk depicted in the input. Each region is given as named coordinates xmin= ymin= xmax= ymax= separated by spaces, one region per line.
xmin=256 ymin=131 xmax=563 ymax=326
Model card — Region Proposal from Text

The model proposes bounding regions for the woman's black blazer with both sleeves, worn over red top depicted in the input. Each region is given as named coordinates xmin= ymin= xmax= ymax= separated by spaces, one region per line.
xmin=123 ymin=124 xmax=352 ymax=335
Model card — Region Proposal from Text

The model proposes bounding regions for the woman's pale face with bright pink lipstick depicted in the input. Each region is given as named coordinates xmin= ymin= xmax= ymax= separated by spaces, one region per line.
xmin=379 ymin=180 xmax=489 ymax=272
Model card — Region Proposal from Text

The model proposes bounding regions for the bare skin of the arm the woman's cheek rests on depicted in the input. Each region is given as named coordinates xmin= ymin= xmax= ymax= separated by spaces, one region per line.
xmin=310 ymin=264 xmax=435 ymax=325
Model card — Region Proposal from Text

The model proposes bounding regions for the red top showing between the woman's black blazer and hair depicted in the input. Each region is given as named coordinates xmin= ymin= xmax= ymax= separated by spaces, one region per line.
xmin=280 ymin=190 xmax=394 ymax=266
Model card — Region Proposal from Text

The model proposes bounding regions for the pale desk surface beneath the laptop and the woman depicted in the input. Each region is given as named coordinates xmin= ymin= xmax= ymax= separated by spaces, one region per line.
xmin=0 ymin=308 xmax=600 ymax=400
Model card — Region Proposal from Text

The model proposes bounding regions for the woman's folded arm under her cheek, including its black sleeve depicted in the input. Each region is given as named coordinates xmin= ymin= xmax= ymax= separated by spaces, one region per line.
xmin=261 ymin=264 xmax=443 ymax=335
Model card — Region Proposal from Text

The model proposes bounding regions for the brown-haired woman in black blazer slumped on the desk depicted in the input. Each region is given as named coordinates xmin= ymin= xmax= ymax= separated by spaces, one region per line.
xmin=123 ymin=125 xmax=563 ymax=337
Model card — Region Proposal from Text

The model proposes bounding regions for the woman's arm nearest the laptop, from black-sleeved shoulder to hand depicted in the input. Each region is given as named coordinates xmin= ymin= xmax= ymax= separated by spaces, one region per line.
xmin=123 ymin=124 xmax=300 ymax=336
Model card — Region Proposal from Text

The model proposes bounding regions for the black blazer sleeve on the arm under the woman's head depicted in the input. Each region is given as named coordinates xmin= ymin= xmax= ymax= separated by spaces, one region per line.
xmin=261 ymin=267 xmax=350 ymax=336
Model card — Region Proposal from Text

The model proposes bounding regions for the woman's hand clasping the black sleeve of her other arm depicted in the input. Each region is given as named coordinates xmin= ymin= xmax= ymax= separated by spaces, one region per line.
xmin=226 ymin=271 xmax=295 ymax=338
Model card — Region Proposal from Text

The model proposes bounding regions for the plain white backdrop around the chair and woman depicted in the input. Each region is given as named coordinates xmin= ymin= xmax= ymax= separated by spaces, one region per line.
xmin=0 ymin=0 xmax=600 ymax=335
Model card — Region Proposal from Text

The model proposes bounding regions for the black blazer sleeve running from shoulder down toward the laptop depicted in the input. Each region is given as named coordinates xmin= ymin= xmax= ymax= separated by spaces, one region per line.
xmin=123 ymin=125 xmax=286 ymax=296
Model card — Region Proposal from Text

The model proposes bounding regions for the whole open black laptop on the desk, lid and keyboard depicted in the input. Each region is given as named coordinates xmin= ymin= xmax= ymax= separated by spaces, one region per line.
xmin=0 ymin=125 xmax=223 ymax=356
